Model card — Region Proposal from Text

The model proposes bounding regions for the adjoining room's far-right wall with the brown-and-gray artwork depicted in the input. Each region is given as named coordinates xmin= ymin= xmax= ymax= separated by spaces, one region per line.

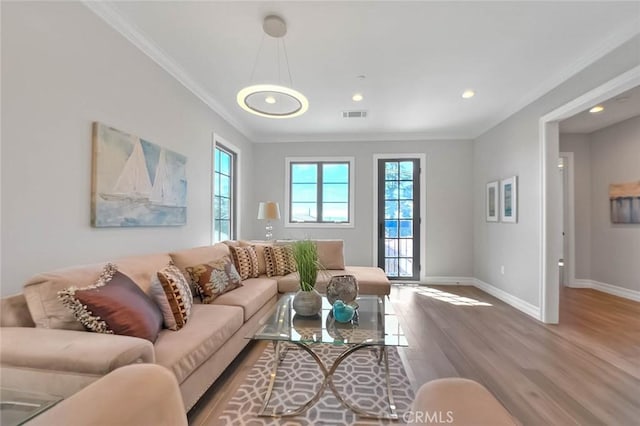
xmin=589 ymin=117 xmax=640 ymax=291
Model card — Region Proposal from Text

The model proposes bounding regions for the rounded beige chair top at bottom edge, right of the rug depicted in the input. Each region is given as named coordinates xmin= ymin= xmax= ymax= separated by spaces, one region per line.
xmin=405 ymin=377 xmax=519 ymax=426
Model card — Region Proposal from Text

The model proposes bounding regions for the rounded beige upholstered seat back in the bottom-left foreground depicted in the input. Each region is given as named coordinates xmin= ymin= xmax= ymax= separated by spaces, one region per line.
xmin=27 ymin=364 xmax=187 ymax=426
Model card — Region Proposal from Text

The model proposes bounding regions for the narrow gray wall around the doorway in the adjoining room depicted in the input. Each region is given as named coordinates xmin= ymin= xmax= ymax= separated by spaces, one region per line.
xmin=560 ymin=133 xmax=591 ymax=279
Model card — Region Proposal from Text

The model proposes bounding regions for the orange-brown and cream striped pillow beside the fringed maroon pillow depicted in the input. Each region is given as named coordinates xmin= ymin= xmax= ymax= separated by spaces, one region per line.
xmin=150 ymin=265 xmax=193 ymax=330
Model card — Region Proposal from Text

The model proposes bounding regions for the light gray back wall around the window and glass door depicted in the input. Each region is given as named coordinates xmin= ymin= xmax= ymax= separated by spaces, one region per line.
xmin=253 ymin=140 xmax=472 ymax=277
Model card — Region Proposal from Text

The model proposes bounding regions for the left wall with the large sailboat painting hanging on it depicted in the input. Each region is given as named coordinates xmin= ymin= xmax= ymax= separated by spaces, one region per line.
xmin=1 ymin=2 xmax=254 ymax=295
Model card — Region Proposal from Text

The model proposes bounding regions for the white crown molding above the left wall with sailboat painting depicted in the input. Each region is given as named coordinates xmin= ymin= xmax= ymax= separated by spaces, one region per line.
xmin=82 ymin=0 xmax=255 ymax=142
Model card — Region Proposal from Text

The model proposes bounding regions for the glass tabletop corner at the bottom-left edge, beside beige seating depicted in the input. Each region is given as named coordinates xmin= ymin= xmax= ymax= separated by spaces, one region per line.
xmin=0 ymin=387 xmax=62 ymax=426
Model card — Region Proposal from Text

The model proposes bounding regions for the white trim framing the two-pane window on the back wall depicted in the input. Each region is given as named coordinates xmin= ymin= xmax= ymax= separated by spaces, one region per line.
xmin=284 ymin=157 xmax=356 ymax=228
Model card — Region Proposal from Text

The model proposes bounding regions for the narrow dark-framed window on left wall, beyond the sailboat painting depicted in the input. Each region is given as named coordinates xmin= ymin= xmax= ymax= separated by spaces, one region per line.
xmin=213 ymin=143 xmax=237 ymax=241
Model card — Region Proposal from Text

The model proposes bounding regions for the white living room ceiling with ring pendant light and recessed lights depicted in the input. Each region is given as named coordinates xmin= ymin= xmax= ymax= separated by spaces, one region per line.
xmin=85 ymin=1 xmax=640 ymax=142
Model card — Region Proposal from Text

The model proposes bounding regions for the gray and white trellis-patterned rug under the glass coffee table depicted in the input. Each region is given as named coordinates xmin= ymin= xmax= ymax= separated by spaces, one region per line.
xmin=218 ymin=344 xmax=414 ymax=426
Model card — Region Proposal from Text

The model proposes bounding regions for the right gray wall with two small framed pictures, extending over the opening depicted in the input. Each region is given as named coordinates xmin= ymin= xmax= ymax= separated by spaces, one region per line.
xmin=473 ymin=36 xmax=640 ymax=307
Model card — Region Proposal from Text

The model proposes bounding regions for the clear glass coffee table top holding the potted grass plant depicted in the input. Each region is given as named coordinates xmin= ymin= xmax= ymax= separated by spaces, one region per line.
xmin=248 ymin=293 xmax=408 ymax=346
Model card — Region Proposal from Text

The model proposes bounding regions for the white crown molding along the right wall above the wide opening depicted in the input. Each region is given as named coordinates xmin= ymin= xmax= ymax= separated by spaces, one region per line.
xmin=473 ymin=18 xmax=640 ymax=139
